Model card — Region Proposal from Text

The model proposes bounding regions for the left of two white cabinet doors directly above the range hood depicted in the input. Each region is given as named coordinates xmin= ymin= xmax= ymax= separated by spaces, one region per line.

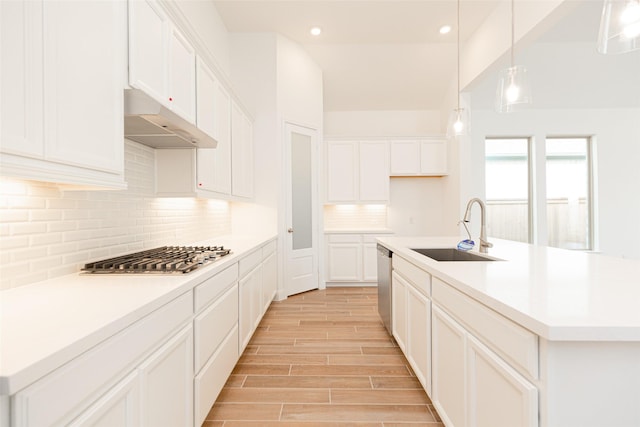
xmin=128 ymin=0 xmax=169 ymax=105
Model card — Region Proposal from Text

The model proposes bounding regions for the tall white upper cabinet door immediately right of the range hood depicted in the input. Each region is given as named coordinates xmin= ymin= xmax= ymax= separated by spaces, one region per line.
xmin=196 ymin=58 xmax=231 ymax=196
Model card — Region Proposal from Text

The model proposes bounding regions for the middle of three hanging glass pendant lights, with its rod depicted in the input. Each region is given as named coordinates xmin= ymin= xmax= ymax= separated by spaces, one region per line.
xmin=496 ymin=0 xmax=532 ymax=113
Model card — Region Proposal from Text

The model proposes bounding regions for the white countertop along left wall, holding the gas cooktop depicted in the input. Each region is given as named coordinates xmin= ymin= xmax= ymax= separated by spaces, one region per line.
xmin=0 ymin=236 xmax=275 ymax=395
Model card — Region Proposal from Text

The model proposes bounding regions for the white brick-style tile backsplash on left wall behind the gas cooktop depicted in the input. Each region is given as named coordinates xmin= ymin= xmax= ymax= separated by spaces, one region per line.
xmin=0 ymin=141 xmax=231 ymax=290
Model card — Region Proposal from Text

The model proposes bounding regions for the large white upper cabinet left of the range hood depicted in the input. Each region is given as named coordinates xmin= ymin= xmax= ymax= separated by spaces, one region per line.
xmin=0 ymin=1 xmax=126 ymax=188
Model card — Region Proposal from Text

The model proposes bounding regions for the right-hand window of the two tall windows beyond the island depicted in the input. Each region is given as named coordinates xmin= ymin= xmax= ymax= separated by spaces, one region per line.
xmin=545 ymin=137 xmax=593 ymax=250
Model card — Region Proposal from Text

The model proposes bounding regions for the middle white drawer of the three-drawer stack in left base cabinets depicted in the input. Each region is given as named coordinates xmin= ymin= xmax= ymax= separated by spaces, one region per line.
xmin=193 ymin=285 xmax=238 ymax=372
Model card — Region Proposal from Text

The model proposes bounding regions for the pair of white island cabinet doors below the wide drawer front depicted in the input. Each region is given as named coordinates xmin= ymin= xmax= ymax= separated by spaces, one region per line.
xmin=432 ymin=306 xmax=538 ymax=427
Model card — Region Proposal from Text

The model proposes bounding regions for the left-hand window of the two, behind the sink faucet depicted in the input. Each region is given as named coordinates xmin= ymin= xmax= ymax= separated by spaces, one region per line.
xmin=485 ymin=138 xmax=531 ymax=243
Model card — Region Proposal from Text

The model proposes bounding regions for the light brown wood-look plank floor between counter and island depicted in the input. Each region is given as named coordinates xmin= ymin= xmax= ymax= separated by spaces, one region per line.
xmin=203 ymin=287 xmax=444 ymax=427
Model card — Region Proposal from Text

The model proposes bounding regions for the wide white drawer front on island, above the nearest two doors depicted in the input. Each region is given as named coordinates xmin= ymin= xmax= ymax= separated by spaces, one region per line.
xmin=432 ymin=277 xmax=538 ymax=379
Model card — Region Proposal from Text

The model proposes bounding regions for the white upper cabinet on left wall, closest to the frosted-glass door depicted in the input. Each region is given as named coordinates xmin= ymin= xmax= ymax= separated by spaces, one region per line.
xmin=231 ymin=100 xmax=254 ymax=198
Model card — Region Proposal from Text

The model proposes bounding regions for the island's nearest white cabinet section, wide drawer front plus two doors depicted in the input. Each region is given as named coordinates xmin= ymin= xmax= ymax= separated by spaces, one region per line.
xmin=432 ymin=279 xmax=539 ymax=427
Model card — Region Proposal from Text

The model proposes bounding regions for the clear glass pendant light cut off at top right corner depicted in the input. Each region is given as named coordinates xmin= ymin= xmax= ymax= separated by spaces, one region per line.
xmin=598 ymin=0 xmax=640 ymax=54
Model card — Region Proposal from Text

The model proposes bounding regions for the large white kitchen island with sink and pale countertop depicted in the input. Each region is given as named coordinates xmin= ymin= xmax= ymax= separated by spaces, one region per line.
xmin=378 ymin=237 xmax=640 ymax=427
